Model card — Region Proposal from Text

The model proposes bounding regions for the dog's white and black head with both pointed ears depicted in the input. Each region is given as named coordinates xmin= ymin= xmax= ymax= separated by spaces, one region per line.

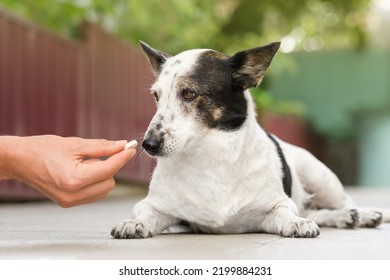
xmin=141 ymin=42 xmax=280 ymax=157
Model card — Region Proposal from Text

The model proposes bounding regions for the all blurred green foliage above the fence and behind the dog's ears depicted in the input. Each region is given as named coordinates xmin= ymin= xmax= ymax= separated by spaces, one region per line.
xmin=0 ymin=0 xmax=370 ymax=118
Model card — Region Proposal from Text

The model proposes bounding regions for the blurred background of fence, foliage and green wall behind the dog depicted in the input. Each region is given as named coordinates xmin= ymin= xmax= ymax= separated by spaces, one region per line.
xmin=0 ymin=0 xmax=390 ymax=201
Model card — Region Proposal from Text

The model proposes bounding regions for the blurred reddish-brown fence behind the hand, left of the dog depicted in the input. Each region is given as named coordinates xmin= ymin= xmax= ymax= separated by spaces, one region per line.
xmin=0 ymin=10 xmax=154 ymax=198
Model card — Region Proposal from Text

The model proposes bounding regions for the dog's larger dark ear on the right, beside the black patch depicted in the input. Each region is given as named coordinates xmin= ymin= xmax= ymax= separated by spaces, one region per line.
xmin=229 ymin=42 xmax=280 ymax=89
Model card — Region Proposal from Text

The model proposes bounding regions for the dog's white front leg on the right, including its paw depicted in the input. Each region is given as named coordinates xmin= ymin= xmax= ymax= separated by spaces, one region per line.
xmin=261 ymin=203 xmax=320 ymax=237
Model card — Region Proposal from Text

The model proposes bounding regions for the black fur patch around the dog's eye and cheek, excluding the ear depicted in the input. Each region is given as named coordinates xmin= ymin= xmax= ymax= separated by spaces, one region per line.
xmin=186 ymin=51 xmax=247 ymax=131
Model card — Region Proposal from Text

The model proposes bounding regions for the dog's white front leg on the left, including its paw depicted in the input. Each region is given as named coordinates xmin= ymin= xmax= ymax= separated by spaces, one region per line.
xmin=111 ymin=200 xmax=178 ymax=239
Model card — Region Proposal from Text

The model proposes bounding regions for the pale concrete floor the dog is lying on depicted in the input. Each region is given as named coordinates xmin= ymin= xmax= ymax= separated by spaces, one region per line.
xmin=0 ymin=187 xmax=390 ymax=260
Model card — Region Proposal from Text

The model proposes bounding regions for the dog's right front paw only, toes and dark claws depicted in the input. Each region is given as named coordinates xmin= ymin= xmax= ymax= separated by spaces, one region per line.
xmin=279 ymin=218 xmax=320 ymax=237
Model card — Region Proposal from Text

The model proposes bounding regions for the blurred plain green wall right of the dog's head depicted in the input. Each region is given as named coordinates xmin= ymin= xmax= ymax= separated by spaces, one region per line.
xmin=271 ymin=51 xmax=390 ymax=138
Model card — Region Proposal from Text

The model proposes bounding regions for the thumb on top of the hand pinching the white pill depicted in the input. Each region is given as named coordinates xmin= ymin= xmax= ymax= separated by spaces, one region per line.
xmin=79 ymin=139 xmax=127 ymax=158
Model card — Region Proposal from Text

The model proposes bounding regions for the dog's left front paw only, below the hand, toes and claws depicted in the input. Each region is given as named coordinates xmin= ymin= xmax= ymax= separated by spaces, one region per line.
xmin=111 ymin=220 xmax=154 ymax=239
